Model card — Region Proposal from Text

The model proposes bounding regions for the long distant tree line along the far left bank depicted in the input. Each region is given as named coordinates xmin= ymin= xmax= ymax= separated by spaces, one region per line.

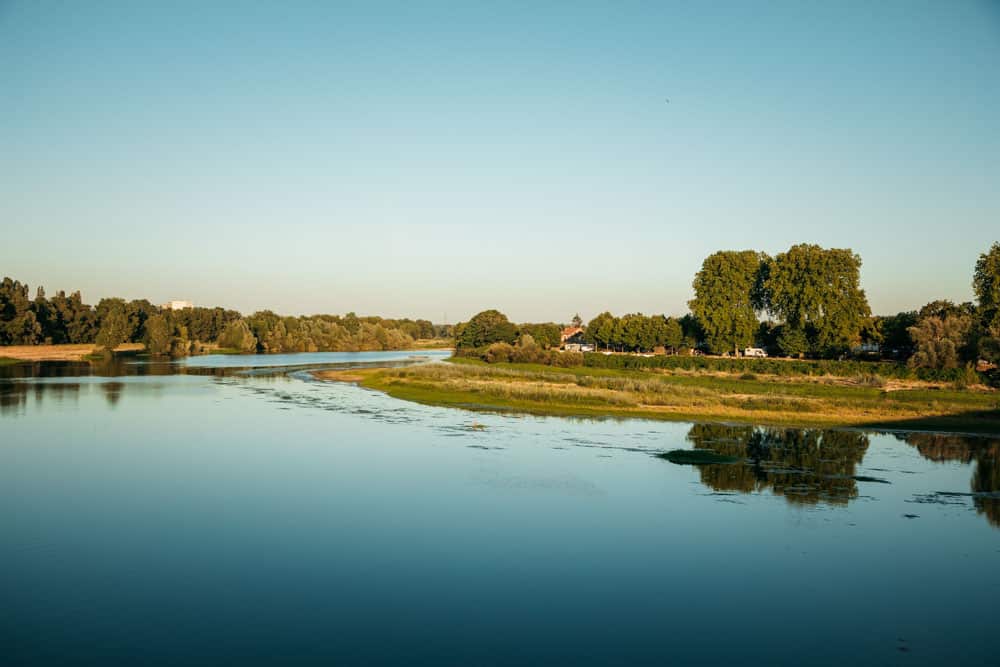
xmin=0 ymin=278 xmax=451 ymax=356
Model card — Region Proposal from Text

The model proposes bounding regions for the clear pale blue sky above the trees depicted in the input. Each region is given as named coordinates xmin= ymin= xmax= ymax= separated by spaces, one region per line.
xmin=0 ymin=0 xmax=1000 ymax=322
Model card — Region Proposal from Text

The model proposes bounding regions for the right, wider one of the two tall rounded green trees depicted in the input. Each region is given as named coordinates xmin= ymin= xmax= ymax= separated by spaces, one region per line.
xmin=762 ymin=244 xmax=871 ymax=356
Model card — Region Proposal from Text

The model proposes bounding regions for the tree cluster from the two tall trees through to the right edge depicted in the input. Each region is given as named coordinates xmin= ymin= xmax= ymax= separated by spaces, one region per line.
xmin=689 ymin=243 xmax=1000 ymax=369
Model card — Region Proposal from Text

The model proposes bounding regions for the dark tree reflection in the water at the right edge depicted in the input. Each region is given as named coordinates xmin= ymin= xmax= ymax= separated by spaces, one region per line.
xmin=896 ymin=433 xmax=1000 ymax=527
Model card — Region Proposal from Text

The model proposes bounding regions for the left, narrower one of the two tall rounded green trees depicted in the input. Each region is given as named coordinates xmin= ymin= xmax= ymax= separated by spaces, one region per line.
xmin=688 ymin=250 xmax=767 ymax=353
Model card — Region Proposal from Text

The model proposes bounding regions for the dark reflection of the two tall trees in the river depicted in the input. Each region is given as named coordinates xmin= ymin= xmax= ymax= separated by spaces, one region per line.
xmin=687 ymin=424 xmax=868 ymax=505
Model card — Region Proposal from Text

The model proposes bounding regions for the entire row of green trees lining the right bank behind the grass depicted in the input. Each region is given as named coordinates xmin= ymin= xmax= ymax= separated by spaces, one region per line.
xmin=454 ymin=243 xmax=1000 ymax=377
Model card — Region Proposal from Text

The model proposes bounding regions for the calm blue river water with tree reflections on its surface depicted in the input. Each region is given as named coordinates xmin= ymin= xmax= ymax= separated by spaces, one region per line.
xmin=0 ymin=353 xmax=1000 ymax=665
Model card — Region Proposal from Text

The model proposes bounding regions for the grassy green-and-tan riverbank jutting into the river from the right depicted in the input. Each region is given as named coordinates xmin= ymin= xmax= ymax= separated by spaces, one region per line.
xmin=315 ymin=359 xmax=1000 ymax=433
